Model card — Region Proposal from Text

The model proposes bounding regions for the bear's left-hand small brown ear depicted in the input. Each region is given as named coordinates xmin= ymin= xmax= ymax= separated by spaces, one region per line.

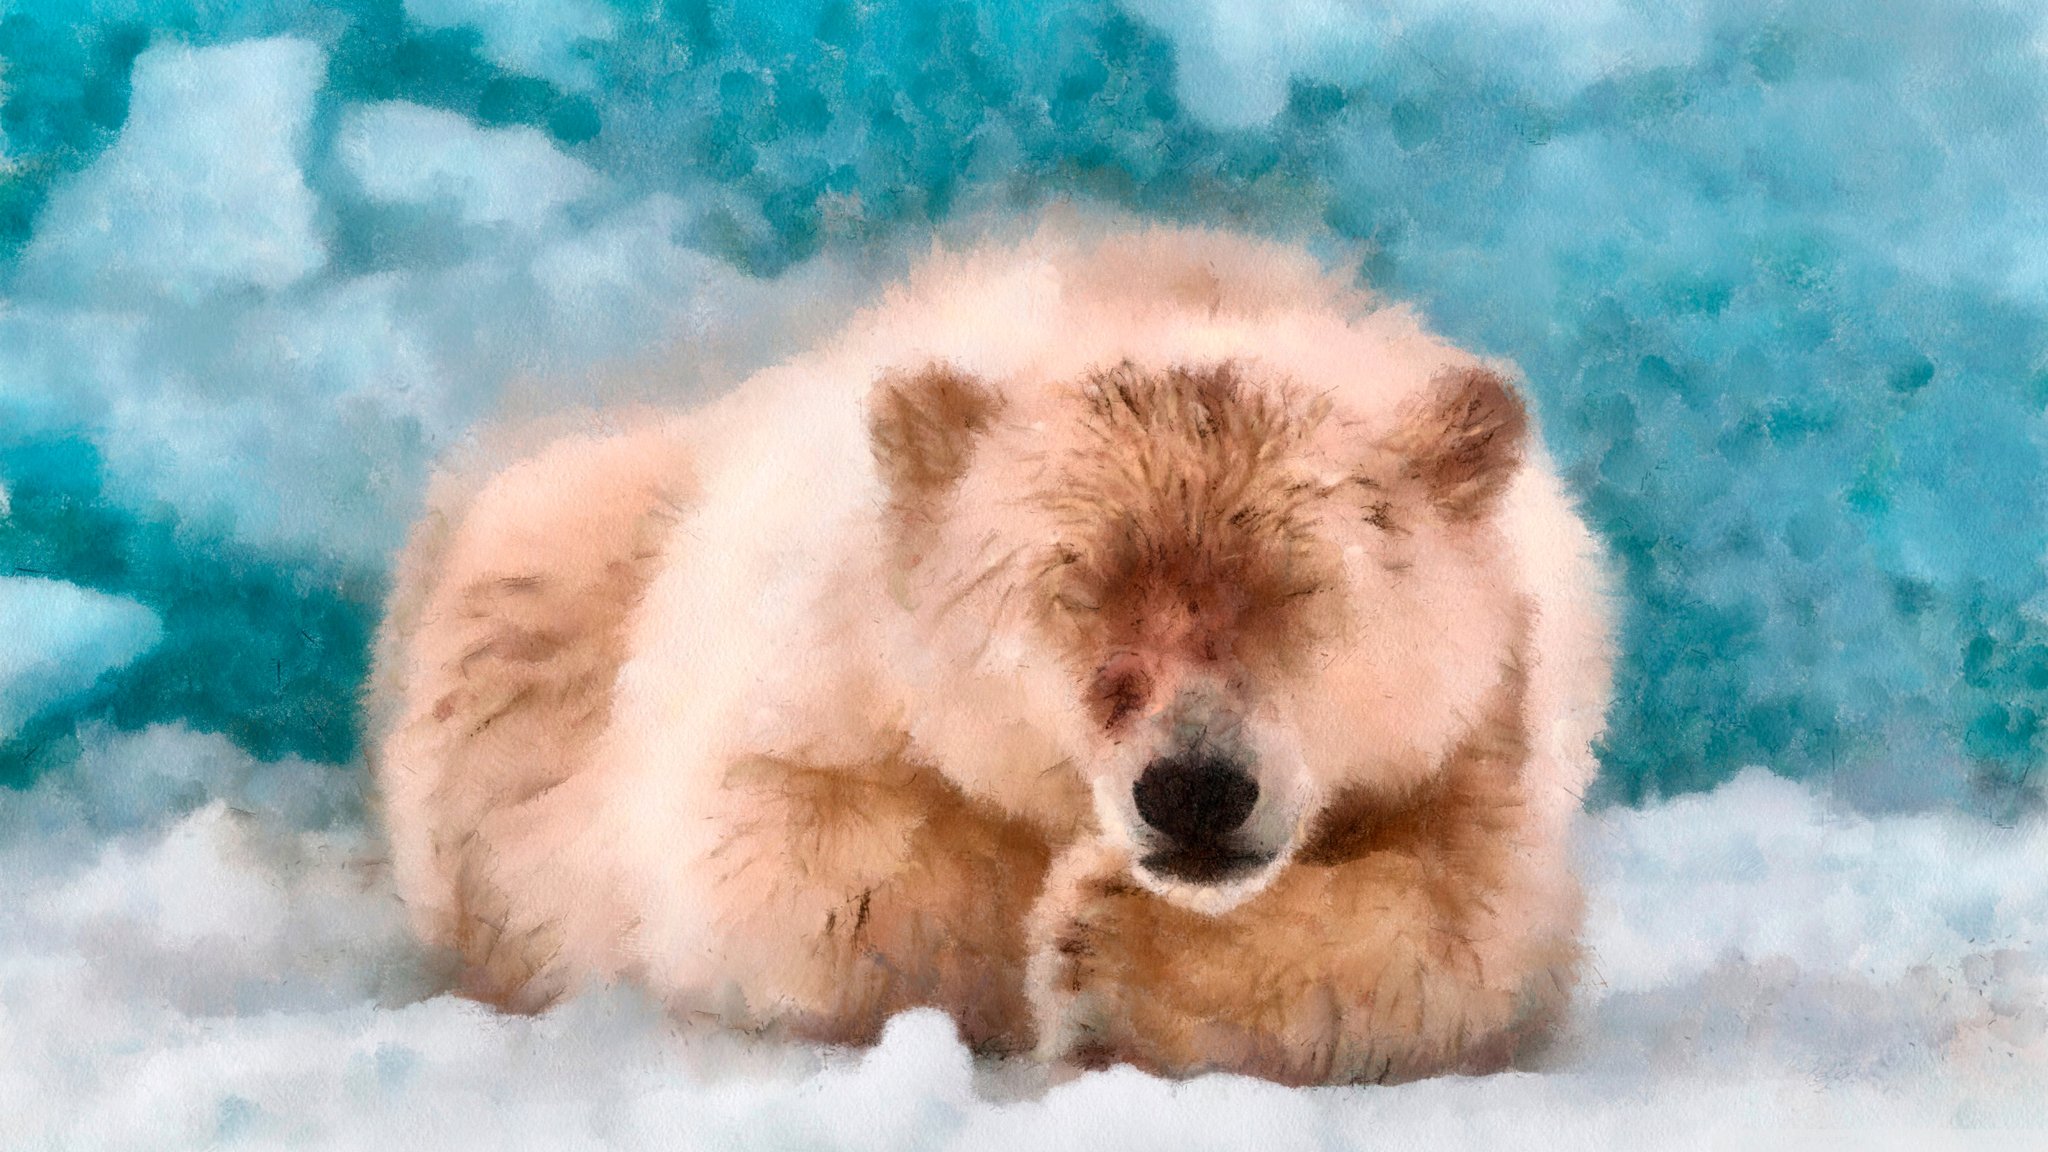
xmin=868 ymin=363 xmax=1004 ymax=504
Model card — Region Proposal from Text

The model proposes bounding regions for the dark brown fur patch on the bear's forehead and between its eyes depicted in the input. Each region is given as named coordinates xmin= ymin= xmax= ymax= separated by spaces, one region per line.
xmin=1038 ymin=365 xmax=1339 ymax=680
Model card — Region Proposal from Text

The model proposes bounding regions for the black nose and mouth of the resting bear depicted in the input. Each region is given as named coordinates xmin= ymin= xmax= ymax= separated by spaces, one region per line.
xmin=1130 ymin=750 xmax=1272 ymax=883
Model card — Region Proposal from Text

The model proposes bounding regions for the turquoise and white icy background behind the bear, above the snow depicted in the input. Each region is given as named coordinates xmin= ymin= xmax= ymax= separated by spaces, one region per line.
xmin=0 ymin=0 xmax=2048 ymax=812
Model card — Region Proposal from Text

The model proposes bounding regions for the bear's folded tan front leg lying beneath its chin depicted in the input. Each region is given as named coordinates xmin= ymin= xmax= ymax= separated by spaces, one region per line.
xmin=1030 ymin=828 xmax=1577 ymax=1084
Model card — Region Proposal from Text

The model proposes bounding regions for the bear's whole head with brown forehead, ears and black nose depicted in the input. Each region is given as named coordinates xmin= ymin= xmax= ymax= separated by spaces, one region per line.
xmin=868 ymin=361 xmax=1528 ymax=912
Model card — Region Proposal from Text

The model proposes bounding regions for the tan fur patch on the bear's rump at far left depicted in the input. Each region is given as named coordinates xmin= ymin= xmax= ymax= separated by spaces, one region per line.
xmin=373 ymin=424 xmax=688 ymax=1011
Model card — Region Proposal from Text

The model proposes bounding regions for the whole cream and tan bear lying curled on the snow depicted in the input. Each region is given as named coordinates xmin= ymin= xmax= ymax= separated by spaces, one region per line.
xmin=367 ymin=221 xmax=1612 ymax=1084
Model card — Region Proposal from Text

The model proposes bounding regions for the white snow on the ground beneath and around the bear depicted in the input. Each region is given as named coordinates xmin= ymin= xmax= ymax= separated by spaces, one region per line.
xmin=0 ymin=728 xmax=2048 ymax=1152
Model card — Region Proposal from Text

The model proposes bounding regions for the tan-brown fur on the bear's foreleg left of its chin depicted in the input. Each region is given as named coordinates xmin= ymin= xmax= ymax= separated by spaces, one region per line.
xmin=711 ymin=760 xmax=1051 ymax=1052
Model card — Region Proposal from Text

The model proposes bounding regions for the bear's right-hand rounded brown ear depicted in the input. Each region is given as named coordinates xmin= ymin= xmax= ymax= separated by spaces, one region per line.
xmin=1386 ymin=367 xmax=1528 ymax=523
